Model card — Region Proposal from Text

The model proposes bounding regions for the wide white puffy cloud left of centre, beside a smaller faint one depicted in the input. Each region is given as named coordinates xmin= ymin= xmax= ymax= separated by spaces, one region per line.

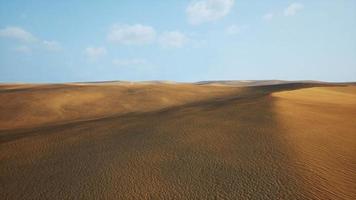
xmin=107 ymin=24 xmax=156 ymax=45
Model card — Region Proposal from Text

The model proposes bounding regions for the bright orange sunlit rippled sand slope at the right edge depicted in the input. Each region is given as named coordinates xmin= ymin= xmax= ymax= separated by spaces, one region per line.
xmin=273 ymin=87 xmax=356 ymax=199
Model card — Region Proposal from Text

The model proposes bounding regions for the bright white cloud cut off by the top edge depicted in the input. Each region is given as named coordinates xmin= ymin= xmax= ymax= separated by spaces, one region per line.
xmin=186 ymin=0 xmax=234 ymax=25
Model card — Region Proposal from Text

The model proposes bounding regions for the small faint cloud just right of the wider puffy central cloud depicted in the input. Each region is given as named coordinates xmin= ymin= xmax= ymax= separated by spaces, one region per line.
xmin=159 ymin=31 xmax=189 ymax=48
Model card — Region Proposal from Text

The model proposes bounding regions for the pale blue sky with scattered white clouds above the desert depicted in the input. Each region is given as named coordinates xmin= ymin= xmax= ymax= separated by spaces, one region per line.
xmin=0 ymin=0 xmax=356 ymax=83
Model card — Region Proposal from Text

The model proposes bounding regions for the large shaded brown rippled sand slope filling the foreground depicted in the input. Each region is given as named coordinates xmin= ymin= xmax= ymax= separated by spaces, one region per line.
xmin=0 ymin=86 xmax=318 ymax=199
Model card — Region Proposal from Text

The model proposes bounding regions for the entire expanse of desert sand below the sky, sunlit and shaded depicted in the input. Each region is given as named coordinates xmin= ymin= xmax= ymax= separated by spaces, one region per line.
xmin=0 ymin=80 xmax=356 ymax=199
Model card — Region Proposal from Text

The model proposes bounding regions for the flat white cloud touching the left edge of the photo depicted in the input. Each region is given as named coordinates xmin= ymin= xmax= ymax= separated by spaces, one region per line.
xmin=0 ymin=26 xmax=38 ymax=42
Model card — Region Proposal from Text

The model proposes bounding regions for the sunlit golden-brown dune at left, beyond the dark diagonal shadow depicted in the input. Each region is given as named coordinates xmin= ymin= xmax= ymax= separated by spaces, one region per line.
xmin=0 ymin=82 xmax=242 ymax=130
